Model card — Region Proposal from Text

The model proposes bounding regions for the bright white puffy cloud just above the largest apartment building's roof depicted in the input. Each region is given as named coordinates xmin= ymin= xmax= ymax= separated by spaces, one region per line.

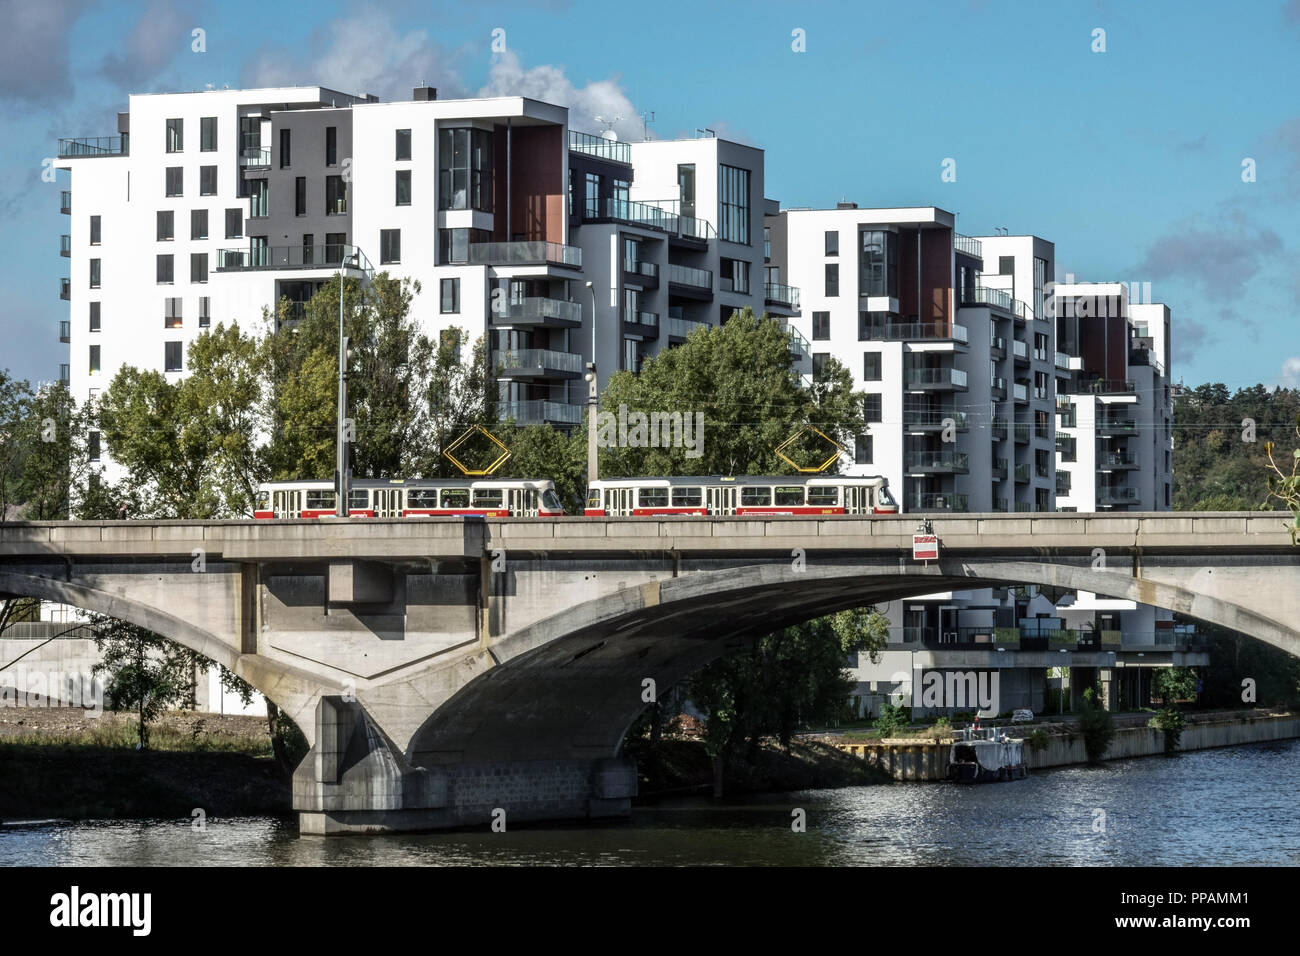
xmin=478 ymin=51 xmax=644 ymax=139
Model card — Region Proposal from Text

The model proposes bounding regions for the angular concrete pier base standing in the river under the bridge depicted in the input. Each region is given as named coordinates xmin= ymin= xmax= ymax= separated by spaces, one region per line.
xmin=294 ymin=696 xmax=637 ymax=836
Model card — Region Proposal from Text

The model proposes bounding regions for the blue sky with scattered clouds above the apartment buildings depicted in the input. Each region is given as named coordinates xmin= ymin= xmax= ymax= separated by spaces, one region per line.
xmin=0 ymin=0 xmax=1300 ymax=388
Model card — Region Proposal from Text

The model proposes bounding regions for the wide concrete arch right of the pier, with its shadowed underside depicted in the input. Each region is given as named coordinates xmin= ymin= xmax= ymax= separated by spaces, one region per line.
xmin=408 ymin=555 xmax=1300 ymax=765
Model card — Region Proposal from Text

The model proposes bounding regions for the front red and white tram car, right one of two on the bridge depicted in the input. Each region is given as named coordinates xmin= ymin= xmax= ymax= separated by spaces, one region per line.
xmin=584 ymin=475 xmax=898 ymax=518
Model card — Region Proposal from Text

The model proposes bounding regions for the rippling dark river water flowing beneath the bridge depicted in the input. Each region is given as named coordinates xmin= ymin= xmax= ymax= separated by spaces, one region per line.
xmin=0 ymin=740 xmax=1300 ymax=866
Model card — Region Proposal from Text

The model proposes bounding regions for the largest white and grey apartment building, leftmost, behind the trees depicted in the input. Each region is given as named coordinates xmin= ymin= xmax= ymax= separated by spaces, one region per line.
xmin=60 ymin=87 xmax=774 ymax=442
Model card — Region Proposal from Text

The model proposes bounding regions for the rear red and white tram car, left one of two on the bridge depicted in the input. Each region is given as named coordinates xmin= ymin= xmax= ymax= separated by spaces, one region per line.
xmin=254 ymin=479 xmax=564 ymax=518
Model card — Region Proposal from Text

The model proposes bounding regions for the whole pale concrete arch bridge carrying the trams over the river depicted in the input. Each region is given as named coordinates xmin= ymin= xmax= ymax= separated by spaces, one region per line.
xmin=0 ymin=512 xmax=1300 ymax=834
